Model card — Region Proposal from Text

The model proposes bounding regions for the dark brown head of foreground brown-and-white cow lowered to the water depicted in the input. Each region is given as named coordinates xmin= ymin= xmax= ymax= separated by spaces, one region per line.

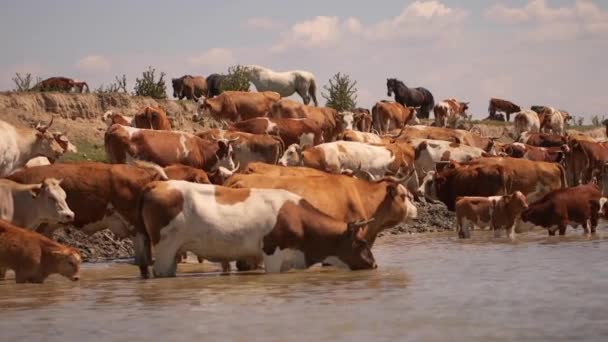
xmin=336 ymin=219 xmax=377 ymax=270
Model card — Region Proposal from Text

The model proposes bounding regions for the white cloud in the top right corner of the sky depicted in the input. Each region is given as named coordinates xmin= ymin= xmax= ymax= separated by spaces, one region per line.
xmin=485 ymin=0 xmax=608 ymax=41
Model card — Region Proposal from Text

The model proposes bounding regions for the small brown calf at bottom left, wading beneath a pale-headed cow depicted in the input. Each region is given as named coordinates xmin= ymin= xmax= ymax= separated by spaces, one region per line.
xmin=0 ymin=220 xmax=82 ymax=283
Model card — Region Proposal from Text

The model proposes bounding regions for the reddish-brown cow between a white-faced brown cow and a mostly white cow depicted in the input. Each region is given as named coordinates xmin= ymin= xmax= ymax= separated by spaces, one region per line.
xmin=196 ymin=129 xmax=285 ymax=169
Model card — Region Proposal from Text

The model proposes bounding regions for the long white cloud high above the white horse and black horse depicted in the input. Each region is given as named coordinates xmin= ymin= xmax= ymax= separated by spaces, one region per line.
xmin=272 ymin=0 xmax=468 ymax=52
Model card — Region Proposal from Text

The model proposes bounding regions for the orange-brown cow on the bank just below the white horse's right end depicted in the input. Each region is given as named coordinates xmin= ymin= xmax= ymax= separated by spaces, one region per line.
xmin=270 ymin=99 xmax=344 ymax=142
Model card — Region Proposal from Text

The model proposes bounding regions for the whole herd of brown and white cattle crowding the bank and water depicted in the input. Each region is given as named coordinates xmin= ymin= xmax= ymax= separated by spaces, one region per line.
xmin=0 ymin=73 xmax=608 ymax=282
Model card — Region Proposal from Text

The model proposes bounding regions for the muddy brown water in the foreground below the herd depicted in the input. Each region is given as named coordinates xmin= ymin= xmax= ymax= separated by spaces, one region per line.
xmin=0 ymin=227 xmax=608 ymax=341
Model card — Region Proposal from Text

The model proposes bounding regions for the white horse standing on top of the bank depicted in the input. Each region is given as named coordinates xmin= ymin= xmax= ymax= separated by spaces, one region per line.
xmin=245 ymin=65 xmax=318 ymax=106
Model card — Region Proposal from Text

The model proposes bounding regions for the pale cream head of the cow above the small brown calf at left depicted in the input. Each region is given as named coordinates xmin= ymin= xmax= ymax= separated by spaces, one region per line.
xmin=30 ymin=178 xmax=75 ymax=223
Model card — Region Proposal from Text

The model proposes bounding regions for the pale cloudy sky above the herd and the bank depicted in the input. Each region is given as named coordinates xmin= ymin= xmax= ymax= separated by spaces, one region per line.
xmin=0 ymin=0 xmax=608 ymax=117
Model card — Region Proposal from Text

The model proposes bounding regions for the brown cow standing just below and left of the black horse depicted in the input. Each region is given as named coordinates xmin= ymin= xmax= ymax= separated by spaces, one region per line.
xmin=372 ymin=100 xmax=418 ymax=134
